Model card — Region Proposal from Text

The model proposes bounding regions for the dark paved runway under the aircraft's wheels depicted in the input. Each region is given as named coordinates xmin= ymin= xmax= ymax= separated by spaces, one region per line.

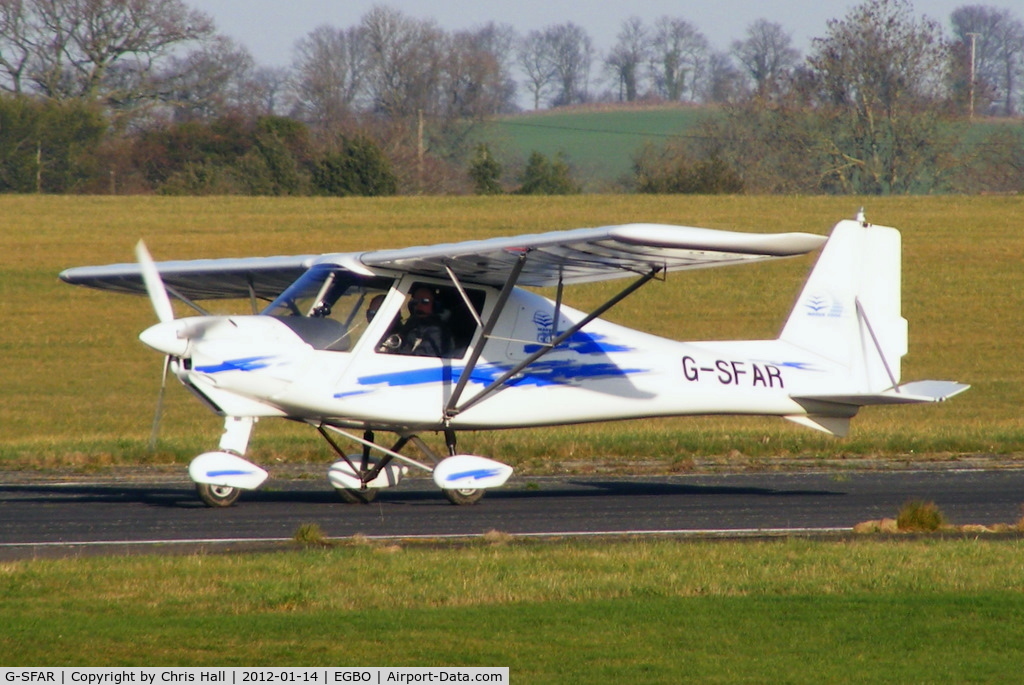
xmin=0 ymin=469 xmax=1024 ymax=558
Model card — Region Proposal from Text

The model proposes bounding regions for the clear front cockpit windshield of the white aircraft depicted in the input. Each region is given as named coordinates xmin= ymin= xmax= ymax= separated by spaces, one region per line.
xmin=260 ymin=264 xmax=394 ymax=352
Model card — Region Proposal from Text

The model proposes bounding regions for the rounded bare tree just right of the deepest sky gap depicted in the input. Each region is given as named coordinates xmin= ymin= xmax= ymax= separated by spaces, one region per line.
xmin=292 ymin=25 xmax=368 ymax=128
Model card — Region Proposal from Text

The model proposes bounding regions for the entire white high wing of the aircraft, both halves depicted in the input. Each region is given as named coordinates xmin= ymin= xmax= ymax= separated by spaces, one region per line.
xmin=60 ymin=223 xmax=825 ymax=300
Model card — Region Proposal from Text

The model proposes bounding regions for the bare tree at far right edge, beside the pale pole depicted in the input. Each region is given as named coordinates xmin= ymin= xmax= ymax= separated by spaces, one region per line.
xmin=949 ymin=5 xmax=1024 ymax=117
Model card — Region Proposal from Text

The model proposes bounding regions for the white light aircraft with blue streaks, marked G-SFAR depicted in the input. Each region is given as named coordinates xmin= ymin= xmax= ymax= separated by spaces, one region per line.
xmin=60 ymin=214 xmax=969 ymax=506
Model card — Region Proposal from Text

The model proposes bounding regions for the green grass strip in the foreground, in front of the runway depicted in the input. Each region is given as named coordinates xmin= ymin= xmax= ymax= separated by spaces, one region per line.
xmin=6 ymin=540 xmax=1024 ymax=683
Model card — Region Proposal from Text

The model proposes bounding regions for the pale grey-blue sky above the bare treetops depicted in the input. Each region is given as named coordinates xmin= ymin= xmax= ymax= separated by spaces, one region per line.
xmin=185 ymin=0 xmax=1024 ymax=67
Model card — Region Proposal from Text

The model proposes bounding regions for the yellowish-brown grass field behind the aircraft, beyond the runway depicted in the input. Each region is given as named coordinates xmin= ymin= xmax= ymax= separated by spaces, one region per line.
xmin=0 ymin=196 xmax=1024 ymax=473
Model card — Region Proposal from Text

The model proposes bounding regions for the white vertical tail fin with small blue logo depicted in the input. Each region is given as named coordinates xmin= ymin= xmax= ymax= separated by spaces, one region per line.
xmin=779 ymin=220 xmax=907 ymax=393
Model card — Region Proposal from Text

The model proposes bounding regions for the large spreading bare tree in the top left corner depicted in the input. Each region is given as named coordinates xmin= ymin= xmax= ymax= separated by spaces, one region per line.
xmin=0 ymin=0 xmax=214 ymax=100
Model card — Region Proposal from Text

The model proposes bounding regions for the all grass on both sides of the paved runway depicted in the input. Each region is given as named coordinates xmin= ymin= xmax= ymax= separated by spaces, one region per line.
xmin=0 ymin=196 xmax=1024 ymax=683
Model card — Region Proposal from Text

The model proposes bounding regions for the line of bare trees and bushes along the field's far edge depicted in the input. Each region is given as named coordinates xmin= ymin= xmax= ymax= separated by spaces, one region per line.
xmin=0 ymin=0 xmax=1024 ymax=195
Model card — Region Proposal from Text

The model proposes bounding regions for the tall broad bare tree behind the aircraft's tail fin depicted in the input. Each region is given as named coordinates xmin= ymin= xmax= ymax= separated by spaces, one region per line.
xmin=808 ymin=0 xmax=948 ymax=194
